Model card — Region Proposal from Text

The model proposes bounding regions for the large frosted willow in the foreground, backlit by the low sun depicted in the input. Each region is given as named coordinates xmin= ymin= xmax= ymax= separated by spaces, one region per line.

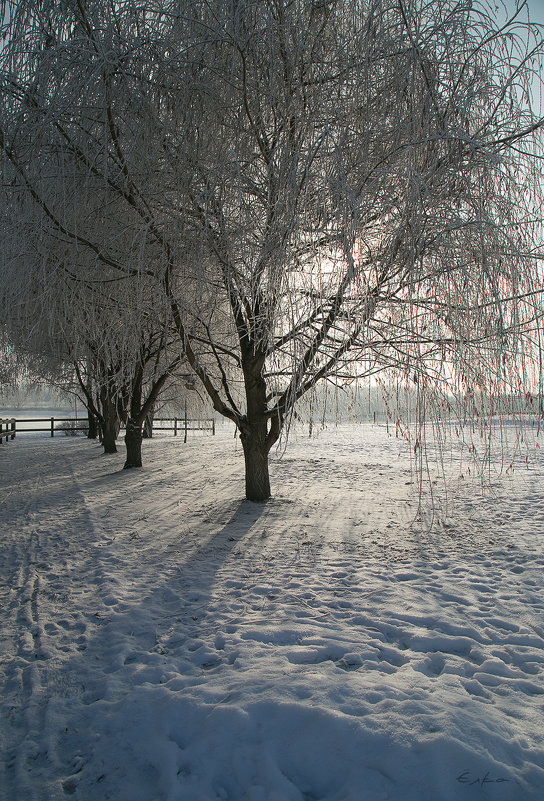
xmin=0 ymin=0 xmax=542 ymax=500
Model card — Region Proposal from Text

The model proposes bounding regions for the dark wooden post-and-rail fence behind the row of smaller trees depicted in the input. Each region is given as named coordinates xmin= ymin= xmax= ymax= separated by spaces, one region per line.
xmin=0 ymin=417 xmax=215 ymax=445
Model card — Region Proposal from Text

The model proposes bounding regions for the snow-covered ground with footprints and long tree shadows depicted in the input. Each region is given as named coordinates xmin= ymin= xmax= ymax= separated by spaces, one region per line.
xmin=0 ymin=425 xmax=544 ymax=801
